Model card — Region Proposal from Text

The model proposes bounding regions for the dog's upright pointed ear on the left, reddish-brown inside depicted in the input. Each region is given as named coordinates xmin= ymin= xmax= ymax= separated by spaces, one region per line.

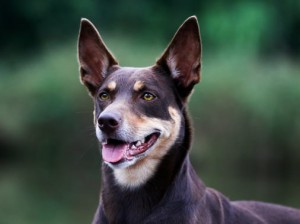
xmin=78 ymin=19 xmax=118 ymax=96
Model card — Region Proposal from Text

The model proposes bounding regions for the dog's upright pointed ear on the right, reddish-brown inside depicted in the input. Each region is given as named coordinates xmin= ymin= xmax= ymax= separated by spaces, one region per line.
xmin=157 ymin=16 xmax=201 ymax=101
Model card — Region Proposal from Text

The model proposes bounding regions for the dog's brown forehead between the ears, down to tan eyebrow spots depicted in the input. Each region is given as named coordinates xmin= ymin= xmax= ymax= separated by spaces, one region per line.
xmin=104 ymin=67 xmax=163 ymax=91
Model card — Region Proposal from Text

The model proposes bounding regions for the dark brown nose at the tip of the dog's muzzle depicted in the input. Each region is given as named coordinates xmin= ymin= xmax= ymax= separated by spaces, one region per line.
xmin=98 ymin=113 xmax=121 ymax=132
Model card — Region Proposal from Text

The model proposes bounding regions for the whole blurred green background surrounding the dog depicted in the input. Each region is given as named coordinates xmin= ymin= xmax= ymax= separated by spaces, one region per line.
xmin=0 ymin=0 xmax=300 ymax=224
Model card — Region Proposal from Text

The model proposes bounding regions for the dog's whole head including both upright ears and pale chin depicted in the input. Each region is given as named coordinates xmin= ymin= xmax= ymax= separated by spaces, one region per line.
xmin=78 ymin=17 xmax=201 ymax=187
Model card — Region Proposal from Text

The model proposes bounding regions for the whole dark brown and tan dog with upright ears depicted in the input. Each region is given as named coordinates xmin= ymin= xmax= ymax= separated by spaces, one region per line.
xmin=78 ymin=17 xmax=300 ymax=224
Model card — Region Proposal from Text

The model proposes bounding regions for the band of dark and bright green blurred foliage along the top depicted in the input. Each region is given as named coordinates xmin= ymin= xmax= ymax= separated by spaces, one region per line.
xmin=0 ymin=0 xmax=300 ymax=57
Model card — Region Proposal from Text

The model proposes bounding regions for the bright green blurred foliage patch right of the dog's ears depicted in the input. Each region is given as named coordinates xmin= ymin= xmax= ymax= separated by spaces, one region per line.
xmin=203 ymin=1 xmax=274 ymax=54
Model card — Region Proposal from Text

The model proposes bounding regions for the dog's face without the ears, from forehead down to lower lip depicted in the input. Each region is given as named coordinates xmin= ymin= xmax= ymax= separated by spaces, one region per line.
xmin=95 ymin=68 xmax=180 ymax=168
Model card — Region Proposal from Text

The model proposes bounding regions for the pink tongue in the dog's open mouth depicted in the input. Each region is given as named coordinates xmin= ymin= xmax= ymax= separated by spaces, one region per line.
xmin=102 ymin=143 xmax=128 ymax=163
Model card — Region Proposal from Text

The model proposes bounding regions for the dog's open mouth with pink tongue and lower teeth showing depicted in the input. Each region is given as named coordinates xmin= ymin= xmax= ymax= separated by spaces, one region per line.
xmin=102 ymin=132 xmax=160 ymax=164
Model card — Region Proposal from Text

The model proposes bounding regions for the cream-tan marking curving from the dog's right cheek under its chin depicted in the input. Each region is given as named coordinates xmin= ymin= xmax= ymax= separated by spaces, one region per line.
xmin=114 ymin=107 xmax=181 ymax=188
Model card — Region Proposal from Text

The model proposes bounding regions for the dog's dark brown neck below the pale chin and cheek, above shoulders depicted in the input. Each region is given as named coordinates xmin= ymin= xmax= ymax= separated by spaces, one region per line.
xmin=101 ymin=111 xmax=205 ymax=223
